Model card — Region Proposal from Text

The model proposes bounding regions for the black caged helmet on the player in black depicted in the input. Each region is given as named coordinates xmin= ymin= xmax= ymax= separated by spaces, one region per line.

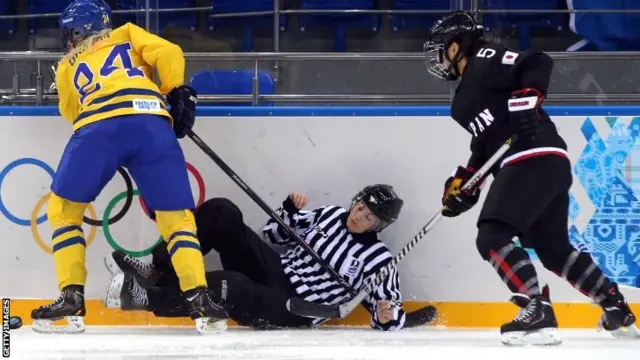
xmin=424 ymin=11 xmax=484 ymax=81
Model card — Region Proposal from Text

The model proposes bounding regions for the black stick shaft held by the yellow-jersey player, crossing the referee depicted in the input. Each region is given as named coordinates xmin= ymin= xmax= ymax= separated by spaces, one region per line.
xmin=187 ymin=129 xmax=358 ymax=296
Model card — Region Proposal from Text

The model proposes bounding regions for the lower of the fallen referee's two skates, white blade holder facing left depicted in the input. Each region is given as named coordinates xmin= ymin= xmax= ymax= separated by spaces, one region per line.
xmin=104 ymin=274 xmax=149 ymax=311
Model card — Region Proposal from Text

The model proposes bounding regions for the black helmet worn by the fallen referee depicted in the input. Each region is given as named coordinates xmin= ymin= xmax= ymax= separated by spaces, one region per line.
xmin=351 ymin=184 xmax=404 ymax=232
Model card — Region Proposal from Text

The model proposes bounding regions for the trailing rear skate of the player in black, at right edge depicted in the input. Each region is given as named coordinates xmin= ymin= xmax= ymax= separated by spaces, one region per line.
xmin=598 ymin=283 xmax=640 ymax=339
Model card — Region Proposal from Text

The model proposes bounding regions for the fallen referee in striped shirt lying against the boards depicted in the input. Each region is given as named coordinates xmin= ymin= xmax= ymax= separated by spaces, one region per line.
xmin=105 ymin=184 xmax=406 ymax=330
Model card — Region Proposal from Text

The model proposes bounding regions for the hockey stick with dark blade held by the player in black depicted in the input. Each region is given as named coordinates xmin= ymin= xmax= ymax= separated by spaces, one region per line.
xmin=287 ymin=135 xmax=517 ymax=319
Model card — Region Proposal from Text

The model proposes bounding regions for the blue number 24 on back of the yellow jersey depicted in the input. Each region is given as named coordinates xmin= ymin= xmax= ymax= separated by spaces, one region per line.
xmin=73 ymin=43 xmax=144 ymax=103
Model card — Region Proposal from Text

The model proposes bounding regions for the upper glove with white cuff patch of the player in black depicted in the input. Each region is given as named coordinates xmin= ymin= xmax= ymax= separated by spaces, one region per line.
xmin=509 ymin=88 xmax=544 ymax=138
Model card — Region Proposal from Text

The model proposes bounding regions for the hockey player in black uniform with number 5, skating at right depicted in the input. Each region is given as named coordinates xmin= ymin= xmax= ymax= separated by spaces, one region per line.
xmin=424 ymin=11 xmax=637 ymax=345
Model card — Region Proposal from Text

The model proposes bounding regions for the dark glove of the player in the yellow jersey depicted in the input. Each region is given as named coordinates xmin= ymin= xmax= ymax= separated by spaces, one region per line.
xmin=167 ymin=85 xmax=198 ymax=139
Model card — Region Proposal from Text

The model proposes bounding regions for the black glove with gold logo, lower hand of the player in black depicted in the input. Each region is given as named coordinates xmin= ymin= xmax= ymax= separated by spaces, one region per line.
xmin=442 ymin=166 xmax=480 ymax=217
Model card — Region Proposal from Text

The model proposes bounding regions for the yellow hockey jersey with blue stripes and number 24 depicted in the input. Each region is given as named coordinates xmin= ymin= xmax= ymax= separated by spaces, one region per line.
xmin=56 ymin=23 xmax=185 ymax=131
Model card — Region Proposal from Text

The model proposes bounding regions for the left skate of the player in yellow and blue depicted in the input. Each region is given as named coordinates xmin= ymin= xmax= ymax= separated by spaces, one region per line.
xmin=31 ymin=285 xmax=87 ymax=334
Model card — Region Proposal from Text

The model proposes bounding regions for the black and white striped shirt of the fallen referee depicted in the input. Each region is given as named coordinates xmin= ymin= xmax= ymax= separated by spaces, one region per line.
xmin=262 ymin=197 xmax=405 ymax=330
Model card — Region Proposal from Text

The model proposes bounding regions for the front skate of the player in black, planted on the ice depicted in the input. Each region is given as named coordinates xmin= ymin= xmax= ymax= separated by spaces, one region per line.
xmin=500 ymin=295 xmax=562 ymax=346
